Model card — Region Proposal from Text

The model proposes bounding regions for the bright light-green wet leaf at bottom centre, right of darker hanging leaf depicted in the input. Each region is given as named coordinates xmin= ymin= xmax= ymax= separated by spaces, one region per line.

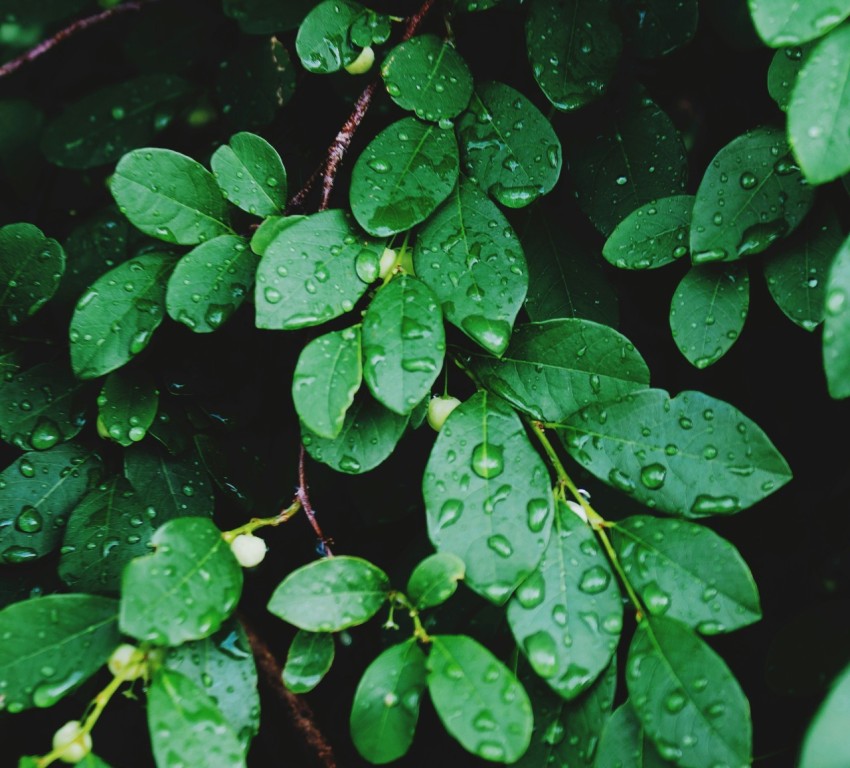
xmin=428 ymin=635 xmax=533 ymax=763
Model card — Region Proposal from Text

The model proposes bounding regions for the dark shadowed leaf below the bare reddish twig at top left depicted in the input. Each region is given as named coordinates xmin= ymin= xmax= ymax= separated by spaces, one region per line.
xmin=42 ymin=73 xmax=192 ymax=168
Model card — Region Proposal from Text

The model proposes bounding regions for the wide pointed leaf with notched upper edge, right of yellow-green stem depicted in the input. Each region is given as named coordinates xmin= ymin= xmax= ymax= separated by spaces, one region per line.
xmin=564 ymin=389 xmax=791 ymax=517
